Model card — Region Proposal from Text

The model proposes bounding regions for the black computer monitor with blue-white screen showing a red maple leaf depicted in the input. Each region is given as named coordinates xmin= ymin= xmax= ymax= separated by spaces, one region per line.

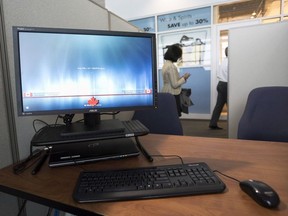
xmin=13 ymin=26 xmax=157 ymax=142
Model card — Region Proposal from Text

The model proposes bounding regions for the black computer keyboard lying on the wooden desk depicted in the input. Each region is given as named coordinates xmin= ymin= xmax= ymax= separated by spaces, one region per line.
xmin=73 ymin=163 xmax=226 ymax=203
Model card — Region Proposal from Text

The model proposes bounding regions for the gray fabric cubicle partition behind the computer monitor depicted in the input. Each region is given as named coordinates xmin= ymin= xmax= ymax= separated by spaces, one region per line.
xmin=0 ymin=0 xmax=138 ymax=216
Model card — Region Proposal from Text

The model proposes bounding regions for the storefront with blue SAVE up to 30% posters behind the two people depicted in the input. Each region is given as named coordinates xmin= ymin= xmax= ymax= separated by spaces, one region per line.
xmin=106 ymin=0 xmax=288 ymax=119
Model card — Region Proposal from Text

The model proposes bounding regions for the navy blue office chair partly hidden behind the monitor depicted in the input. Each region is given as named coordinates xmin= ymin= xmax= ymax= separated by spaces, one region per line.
xmin=132 ymin=93 xmax=183 ymax=135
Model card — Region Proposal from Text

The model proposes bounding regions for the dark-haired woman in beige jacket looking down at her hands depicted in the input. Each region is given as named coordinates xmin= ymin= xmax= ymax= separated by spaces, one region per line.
xmin=162 ymin=44 xmax=190 ymax=116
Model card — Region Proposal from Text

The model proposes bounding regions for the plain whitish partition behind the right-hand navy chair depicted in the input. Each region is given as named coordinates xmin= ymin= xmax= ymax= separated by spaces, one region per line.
xmin=228 ymin=21 xmax=288 ymax=138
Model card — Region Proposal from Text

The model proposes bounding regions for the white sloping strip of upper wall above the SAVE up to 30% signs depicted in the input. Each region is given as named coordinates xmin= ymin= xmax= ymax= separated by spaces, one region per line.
xmin=105 ymin=0 xmax=235 ymax=20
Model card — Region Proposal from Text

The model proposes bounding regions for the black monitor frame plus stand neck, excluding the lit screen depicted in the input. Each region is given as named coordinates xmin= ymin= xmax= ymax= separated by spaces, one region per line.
xmin=13 ymin=26 xmax=157 ymax=143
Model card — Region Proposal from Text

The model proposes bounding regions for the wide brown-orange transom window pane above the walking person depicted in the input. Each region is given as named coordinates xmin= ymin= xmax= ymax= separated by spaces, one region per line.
xmin=213 ymin=0 xmax=287 ymax=23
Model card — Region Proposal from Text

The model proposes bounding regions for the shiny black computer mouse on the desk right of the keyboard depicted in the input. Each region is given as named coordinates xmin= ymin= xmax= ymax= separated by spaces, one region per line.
xmin=239 ymin=179 xmax=280 ymax=208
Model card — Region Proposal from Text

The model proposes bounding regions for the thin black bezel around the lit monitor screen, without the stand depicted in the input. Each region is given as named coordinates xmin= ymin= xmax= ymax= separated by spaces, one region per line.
xmin=12 ymin=26 xmax=157 ymax=116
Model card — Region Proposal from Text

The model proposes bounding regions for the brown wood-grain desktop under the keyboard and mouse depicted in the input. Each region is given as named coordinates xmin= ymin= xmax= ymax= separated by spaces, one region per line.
xmin=0 ymin=134 xmax=288 ymax=216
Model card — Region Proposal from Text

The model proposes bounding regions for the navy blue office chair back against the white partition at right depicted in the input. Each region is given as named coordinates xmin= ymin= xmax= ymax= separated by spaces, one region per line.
xmin=238 ymin=86 xmax=288 ymax=142
